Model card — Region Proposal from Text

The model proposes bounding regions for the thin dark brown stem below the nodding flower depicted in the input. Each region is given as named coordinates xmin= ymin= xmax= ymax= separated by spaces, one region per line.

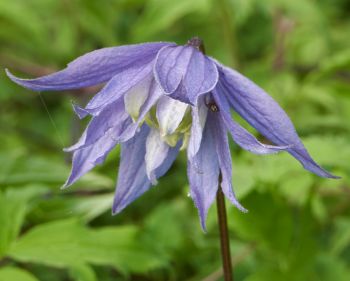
xmin=216 ymin=185 xmax=233 ymax=281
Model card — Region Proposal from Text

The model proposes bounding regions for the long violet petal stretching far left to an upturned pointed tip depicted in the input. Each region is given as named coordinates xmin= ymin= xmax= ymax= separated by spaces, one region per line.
xmin=6 ymin=42 xmax=174 ymax=91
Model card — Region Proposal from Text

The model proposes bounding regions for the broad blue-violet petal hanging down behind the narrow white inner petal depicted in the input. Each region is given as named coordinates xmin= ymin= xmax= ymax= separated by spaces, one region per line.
xmin=112 ymin=125 xmax=177 ymax=214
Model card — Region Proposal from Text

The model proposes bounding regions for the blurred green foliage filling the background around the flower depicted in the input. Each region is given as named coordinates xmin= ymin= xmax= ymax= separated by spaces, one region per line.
xmin=0 ymin=0 xmax=350 ymax=281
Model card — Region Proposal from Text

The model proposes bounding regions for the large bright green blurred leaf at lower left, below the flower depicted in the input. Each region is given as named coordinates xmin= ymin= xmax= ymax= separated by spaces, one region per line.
xmin=9 ymin=219 xmax=162 ymax=272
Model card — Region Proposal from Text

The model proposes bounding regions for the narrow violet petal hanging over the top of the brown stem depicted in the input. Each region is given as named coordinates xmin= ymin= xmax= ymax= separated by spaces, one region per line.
xmin=208 ymin=112 xmax=247 ymax=212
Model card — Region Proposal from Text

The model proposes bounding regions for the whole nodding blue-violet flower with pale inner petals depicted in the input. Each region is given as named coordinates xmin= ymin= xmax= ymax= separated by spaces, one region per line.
xmin=7 ymin=37 xmax=336 ymax=229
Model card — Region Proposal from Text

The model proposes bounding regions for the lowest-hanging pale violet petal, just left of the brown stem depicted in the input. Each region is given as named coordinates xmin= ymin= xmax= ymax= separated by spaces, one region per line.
xmin=187 ymin=116 xmax=219 ymax=231
